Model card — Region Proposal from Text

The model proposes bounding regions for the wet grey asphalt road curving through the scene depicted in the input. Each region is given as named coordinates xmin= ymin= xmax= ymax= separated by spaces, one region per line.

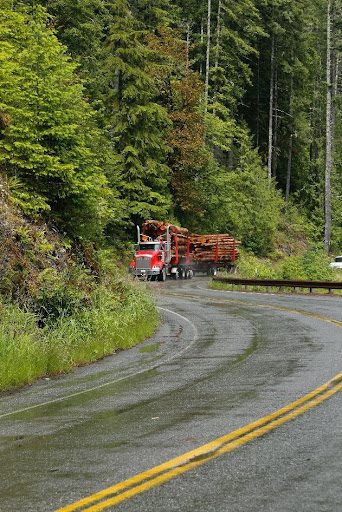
xmin=0 ymin=278 xmax=342 ymax=512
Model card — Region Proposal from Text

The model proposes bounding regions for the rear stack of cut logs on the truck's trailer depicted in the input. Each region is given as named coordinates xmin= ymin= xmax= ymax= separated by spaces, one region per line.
xmin=191 ymin=233 xmax=241 ymax=262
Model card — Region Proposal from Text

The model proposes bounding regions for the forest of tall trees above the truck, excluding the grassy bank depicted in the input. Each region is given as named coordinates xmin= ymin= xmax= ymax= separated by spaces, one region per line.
xmin=0 ymin=0 xmax=342 ymax=256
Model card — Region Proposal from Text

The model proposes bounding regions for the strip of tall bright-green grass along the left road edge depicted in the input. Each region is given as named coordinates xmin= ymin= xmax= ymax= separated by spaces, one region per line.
xmin=0 ymin=282 xmax=159 ymax=390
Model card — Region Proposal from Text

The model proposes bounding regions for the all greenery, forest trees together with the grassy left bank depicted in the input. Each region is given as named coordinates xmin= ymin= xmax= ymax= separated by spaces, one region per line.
xmin=0 ymin=0 xmax=342 ymax=389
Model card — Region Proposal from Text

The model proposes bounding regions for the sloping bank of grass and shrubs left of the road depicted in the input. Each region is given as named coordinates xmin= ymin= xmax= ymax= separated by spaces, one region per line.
xmin=0 ymin=197 xmax=159 ymax=390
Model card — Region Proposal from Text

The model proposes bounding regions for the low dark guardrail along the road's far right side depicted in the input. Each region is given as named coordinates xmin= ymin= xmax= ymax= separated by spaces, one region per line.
xmin=213 ymin=276 xmax=342 ymax=293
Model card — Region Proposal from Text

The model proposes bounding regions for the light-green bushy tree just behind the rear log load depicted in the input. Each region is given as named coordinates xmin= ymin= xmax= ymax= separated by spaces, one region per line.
xmin=206 ymin=129 xmax=283 ymax=256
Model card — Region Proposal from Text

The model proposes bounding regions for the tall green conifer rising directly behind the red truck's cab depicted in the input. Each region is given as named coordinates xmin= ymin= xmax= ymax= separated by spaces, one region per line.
xmin=106 ymin=0 xmax=170 ymax=222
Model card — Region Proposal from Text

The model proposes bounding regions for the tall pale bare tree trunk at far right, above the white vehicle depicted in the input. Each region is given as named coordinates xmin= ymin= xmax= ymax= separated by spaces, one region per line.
xmin=324 ymin=0 xmax=333 ymax=253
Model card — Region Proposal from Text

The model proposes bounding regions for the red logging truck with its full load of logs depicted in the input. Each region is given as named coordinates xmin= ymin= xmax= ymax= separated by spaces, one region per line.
xmin=129 ymin=220 xmax=240 ymax=281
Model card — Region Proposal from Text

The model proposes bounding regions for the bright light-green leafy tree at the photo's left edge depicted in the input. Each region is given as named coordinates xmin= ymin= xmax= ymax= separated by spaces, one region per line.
xmin=0 ymin=6 xmax=111 ymax=236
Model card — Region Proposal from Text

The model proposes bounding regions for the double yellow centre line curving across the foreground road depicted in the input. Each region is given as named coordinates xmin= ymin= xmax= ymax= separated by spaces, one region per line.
xmin=55 ymin=373 xmax=342 ymax=512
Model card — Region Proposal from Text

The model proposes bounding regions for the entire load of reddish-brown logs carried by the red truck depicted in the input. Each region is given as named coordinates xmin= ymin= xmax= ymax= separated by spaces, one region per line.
xmin=142 ymin=220 xmax=241 ymax=262
